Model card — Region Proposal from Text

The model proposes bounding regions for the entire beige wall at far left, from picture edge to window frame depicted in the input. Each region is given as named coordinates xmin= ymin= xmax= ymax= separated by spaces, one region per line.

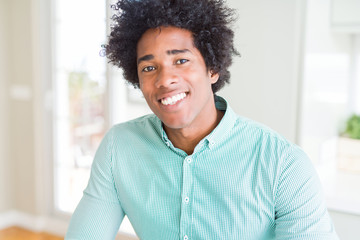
xmin=0 ymin=0 xmax=36 ymax=213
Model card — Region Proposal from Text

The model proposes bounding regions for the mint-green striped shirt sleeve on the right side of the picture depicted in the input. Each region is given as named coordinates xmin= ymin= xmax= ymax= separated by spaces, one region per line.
xmin=275 ymin=146 xmax=338 ymax=240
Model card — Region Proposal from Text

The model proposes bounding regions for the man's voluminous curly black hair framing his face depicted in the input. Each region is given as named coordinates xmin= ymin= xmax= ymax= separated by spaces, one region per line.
xmin=105 ymin=0 xmax=238 ymax=93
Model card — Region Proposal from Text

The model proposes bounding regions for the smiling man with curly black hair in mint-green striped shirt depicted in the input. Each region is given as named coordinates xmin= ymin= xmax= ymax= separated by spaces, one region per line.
xmin=66 ymin=0 xmax=337 ymax=240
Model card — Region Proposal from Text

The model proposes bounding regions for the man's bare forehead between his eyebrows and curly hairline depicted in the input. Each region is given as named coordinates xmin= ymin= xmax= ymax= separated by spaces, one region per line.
xmin=137 ymin=26 xmax=195 ymax=58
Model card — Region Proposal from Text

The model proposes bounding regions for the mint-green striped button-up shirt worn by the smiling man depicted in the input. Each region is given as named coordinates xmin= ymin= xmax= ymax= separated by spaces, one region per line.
xmin=65 ymin=96 xmax=338 ymax=240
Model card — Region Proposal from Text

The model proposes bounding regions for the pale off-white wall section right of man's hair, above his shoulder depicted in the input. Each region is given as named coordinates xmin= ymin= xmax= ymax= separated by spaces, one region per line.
xmin=219 ymin=0 xmax=304 ymax=142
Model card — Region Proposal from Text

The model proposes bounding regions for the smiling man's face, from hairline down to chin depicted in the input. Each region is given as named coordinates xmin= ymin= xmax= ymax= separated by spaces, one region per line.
xmin=137 ymin=27 xmax=218 ymax=129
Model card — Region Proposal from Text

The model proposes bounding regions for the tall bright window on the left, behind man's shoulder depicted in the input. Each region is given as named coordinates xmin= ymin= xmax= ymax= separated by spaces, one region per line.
xmin=53 ymin=0 xmax=150 ymax=219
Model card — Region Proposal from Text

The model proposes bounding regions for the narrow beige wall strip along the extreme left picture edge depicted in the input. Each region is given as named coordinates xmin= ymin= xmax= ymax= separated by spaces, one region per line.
xmin=0 ymin=0 xmax=11 ymax=212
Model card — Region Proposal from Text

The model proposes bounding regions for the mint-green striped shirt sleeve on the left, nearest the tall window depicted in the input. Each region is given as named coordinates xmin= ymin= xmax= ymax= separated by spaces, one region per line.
xmin=65 ymin=130 xmax=124 ymax=240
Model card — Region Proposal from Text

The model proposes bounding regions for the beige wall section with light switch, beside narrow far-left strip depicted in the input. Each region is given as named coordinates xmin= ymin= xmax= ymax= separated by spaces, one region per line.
xmin=7 ymin=0 xmax=36 ymax=214
